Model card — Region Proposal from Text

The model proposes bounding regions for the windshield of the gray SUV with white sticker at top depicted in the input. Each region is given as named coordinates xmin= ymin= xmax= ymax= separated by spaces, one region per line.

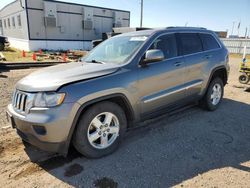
xmin=83 ymin=36 xmax=148 ymax=64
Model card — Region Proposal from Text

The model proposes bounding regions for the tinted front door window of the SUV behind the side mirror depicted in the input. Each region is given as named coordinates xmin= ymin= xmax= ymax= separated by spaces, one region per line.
xmin=149 ymin=34 xmax=178 ymax=59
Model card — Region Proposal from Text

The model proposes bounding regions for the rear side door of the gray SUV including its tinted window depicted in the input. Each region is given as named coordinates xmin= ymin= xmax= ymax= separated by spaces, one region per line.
xmin=178 ymin=33 xmax=208 ymax=97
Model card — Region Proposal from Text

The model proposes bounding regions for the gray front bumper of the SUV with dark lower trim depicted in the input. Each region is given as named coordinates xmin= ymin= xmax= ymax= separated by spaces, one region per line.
xmin=7 ymin=103 xmax=79 ymax=154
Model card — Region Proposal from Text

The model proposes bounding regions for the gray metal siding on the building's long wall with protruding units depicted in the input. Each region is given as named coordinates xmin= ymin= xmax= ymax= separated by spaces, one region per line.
xmin=28 ymin=0 xmax=130 ymax=40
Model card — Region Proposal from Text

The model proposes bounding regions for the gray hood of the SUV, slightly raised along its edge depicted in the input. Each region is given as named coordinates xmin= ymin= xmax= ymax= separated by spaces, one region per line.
xmin=16 ymin=62 xmax=120 ymax=92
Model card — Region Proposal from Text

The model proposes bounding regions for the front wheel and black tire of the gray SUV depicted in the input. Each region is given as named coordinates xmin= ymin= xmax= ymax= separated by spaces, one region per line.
xmin=73 ymin=102 xmax=127 ymax=158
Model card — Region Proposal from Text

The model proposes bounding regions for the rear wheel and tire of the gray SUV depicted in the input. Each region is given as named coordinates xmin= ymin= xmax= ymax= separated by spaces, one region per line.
xmin=201 ymin=77 xmax=224 ymax=111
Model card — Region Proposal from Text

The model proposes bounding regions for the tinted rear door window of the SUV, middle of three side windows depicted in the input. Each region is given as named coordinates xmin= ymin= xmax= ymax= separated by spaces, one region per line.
xmin=179 ymin=33 xmax=203 ymax=55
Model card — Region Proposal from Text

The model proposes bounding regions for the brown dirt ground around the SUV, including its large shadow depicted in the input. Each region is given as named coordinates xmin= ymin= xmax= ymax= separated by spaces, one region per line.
xmin=0 ymin=58 xmax=250 ymax=187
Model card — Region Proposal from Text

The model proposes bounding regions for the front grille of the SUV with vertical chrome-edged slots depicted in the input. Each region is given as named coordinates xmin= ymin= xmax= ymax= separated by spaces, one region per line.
xmin=13 ymin=91 xmax=28 ymax=112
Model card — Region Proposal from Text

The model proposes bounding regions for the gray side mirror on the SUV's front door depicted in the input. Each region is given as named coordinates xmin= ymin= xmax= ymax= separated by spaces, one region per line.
xmin=141 ymin=49 xmax=165 ymax=66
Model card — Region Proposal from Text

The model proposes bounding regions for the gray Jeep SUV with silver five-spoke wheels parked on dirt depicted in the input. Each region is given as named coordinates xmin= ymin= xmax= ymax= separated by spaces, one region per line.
xmin=7 ymin=27 xmax=229 ymax=158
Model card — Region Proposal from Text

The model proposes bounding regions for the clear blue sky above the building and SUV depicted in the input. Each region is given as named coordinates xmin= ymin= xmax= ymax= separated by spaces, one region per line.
xmin=0 ymin=0 xmax=250 ymax=35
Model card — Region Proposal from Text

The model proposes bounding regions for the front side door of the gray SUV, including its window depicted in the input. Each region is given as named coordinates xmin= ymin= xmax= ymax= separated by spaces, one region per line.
xmin=138 ymin=34 xmax=185 ymax=114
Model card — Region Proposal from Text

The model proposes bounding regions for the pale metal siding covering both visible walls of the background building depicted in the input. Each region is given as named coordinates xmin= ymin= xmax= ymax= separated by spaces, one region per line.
xmin=0 ymin=0 xmax=130 ymax=41
